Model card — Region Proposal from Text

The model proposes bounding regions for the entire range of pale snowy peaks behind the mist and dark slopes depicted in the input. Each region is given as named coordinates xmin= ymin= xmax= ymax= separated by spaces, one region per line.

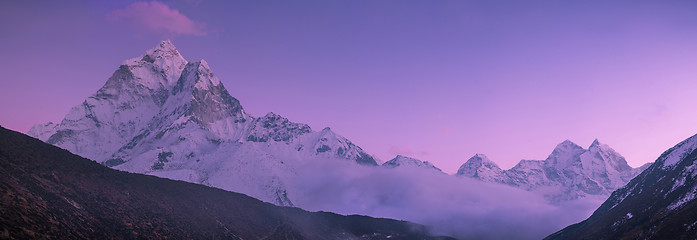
xmin=28 ymin=41 xmax=646 ymax=206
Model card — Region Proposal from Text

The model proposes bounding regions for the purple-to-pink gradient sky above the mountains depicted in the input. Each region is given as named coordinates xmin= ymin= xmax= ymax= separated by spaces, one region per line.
xmin=0 ymin=0 xmax=697 ymax=173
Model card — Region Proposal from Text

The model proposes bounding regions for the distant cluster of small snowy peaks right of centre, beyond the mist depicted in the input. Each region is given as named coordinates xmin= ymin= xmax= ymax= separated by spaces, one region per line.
xmin=457 ymin=140 xmax=649 ymax=202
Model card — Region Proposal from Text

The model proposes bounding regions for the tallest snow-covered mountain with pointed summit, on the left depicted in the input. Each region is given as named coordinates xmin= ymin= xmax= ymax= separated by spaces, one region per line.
xmin=28 ymin=41 xmax=377 ymax=205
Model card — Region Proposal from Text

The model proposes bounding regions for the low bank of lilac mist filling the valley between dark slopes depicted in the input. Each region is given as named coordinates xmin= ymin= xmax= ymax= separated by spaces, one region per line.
xmin=290 ymin=162 xmax=604 ymax=239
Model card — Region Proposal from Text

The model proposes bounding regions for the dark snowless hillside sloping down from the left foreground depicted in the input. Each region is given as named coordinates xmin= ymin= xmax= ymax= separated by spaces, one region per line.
xmin=0 ymin=127 xmax=452 ymax=239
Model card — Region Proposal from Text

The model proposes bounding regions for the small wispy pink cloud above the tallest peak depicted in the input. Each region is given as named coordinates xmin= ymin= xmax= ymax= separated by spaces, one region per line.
xmin=108 ymin=1 xmax=206 ymax=36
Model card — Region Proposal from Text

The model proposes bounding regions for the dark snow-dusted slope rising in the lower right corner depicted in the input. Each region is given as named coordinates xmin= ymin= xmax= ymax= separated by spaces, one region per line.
xmin=546 ymin=135 xmax=697 ymax=239
